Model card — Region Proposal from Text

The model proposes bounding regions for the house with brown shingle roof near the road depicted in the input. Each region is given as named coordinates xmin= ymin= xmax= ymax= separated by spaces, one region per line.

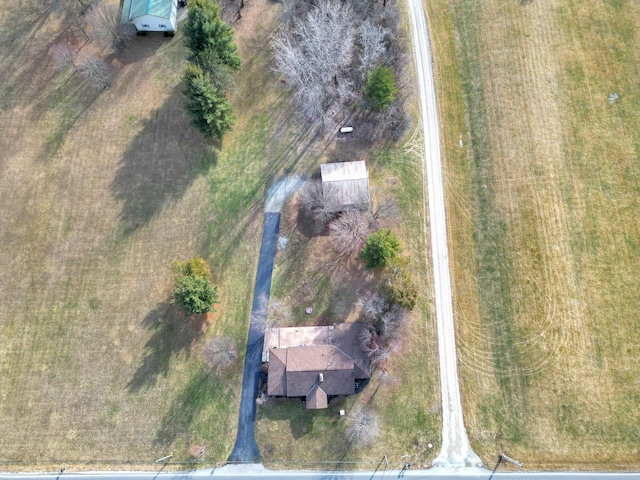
xmin=263 ymin=323 xmax=371 ymax=409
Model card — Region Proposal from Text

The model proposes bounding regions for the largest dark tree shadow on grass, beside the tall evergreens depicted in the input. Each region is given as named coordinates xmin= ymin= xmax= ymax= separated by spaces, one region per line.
xmin=111 ymin=88 xmax=217 ymax=235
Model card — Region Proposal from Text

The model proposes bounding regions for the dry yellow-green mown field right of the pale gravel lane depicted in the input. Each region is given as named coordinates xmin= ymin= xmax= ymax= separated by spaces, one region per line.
xmin=427 ymin=0 xmax=640 ymax=469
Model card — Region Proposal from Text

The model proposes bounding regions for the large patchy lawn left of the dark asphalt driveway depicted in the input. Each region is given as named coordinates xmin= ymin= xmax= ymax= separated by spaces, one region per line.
xmin=0 ymin=2 xmax=304 ymax=468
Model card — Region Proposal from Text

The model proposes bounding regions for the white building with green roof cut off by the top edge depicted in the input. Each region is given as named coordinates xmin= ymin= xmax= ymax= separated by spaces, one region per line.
xmin=122 ymin=0 xmax=178 ymax=32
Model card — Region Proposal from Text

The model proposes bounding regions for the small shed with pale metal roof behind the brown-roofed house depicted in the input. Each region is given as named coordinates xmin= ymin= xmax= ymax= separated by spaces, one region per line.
xmin=320 ymin=160 xmax=370 ymax=211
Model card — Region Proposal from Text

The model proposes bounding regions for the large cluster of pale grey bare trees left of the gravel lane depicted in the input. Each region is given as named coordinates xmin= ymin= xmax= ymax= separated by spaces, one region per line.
xmin=272 ymin=0 xmax=405 ymax=133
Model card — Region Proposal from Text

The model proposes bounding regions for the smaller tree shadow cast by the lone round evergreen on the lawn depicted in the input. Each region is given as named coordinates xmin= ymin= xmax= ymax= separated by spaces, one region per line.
xmin=127 ymin=302 xmax=206 ymax=392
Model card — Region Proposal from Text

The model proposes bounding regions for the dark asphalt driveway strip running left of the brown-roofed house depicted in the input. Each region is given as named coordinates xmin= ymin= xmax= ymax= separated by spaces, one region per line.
xmin=229 ymin=212 xmax=280 ymax=463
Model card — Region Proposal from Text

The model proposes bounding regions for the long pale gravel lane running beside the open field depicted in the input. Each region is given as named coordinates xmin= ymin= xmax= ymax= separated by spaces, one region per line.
xmin=407 ymin=0 xmax=482 ymax=467
